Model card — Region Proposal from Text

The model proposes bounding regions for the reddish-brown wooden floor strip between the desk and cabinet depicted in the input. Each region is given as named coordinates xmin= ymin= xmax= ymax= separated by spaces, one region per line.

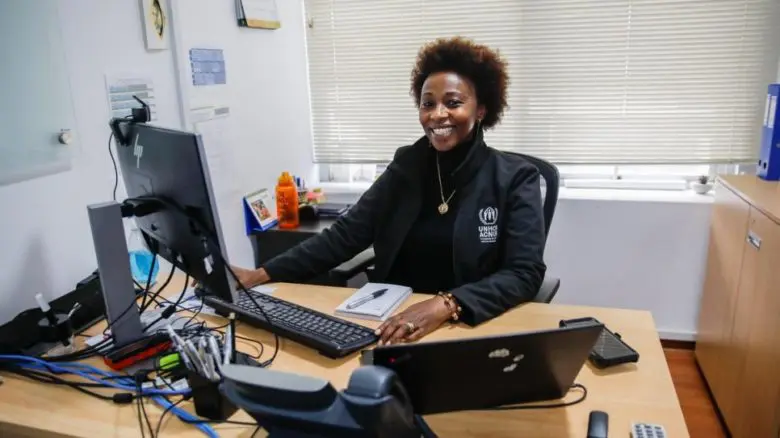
xmin=664 ymin=348 xmax=726 ymax=438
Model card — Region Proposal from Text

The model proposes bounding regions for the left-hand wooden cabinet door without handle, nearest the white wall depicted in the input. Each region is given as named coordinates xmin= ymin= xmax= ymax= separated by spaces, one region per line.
xmin=696 ymin=181 xmax=750 ymax=428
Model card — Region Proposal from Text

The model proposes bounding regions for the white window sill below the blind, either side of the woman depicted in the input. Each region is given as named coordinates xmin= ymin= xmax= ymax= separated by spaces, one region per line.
xmin=315 ymin=182 xmax=715 ymax=204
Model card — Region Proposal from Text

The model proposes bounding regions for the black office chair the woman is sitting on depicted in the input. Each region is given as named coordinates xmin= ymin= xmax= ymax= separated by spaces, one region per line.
xmin=330 ymin=152 xmax=561 ymax=303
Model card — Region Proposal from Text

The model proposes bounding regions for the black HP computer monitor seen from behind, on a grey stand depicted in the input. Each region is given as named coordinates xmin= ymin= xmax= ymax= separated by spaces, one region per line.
xmin=117 ymin=123 xmax=237 ymax=303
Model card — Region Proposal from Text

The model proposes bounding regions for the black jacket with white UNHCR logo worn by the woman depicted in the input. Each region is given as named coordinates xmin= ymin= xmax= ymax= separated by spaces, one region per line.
xmin=264 ymin=132 xmax=546 ymax=325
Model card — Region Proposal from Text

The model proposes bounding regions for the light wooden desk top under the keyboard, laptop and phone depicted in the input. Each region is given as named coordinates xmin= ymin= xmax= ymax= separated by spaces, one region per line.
xmin=0 ymin=278 xmax=688 ymax=438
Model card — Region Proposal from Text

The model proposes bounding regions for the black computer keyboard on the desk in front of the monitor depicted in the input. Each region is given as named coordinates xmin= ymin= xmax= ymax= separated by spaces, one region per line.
xmin=204 ymin=291 xmax=378 ymax=358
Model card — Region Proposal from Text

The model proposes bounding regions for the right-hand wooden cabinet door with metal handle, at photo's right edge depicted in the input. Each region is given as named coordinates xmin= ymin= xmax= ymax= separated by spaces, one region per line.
xmin=732 ymin=209 xmax=780 ymax=438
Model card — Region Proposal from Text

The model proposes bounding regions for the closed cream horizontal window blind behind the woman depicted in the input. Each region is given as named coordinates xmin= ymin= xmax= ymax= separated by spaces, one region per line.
xmin=305 ymin=0 xmax=780 ymax=164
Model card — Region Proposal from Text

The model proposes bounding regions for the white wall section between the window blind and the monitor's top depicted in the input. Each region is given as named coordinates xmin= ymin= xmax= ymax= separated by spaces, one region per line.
xmin=173 ymin=0 xmax=313 ymax=266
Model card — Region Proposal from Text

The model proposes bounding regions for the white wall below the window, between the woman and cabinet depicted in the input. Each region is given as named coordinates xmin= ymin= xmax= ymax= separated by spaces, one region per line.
xmin=545 ymin=195 xmax=712 ymax=340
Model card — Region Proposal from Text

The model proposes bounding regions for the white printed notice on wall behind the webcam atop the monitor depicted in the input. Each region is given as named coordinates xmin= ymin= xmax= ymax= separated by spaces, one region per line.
xmin=106 ymin=74 xmax=157 ymax=121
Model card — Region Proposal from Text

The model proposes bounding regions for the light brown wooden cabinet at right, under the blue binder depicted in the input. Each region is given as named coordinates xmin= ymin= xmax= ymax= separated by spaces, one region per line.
xmin=696 ymin=176 xmax=780 ymax=438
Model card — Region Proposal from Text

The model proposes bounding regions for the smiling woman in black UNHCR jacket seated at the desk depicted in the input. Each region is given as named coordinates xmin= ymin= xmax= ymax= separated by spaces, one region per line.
xmin=230 ymin=38 xmax=546 ymax=344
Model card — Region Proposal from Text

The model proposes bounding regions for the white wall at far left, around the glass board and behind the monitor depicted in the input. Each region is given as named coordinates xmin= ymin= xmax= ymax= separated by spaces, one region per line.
xmin=0 ymin=0 xmax=180 ymax=323
